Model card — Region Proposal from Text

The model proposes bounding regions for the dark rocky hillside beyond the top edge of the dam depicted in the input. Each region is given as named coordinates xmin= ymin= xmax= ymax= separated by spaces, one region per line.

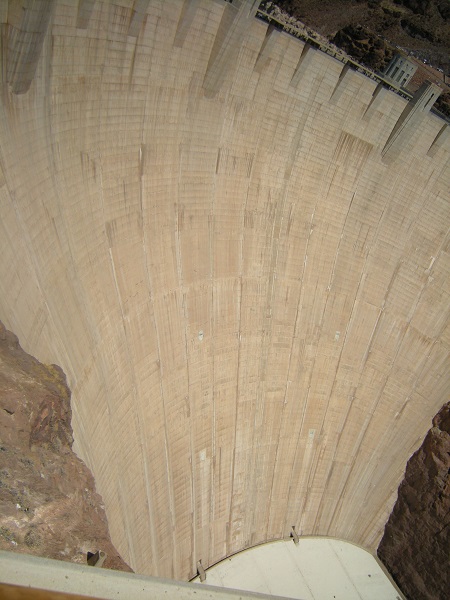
xmin=268 ymin=0 xmax=450 ymax=117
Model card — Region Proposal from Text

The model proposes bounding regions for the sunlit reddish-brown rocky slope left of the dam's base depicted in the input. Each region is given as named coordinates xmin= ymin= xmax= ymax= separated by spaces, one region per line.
xmin=0 ymin=322 xmax=131 ymax=571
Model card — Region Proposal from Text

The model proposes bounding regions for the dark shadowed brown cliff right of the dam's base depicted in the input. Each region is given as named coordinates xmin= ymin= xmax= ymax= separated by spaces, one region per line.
xmin=378 ymin=402 xmax=450 ymax=600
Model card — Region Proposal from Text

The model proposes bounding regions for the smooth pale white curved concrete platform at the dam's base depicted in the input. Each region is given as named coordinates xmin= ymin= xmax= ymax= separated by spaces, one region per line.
xmin=194 ymin=537 xmax=404 ymax=600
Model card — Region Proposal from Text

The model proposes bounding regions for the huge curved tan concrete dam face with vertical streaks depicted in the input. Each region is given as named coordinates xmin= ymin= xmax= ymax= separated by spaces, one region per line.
xmin=0 ymin=0 xmax=450 ymax=579
